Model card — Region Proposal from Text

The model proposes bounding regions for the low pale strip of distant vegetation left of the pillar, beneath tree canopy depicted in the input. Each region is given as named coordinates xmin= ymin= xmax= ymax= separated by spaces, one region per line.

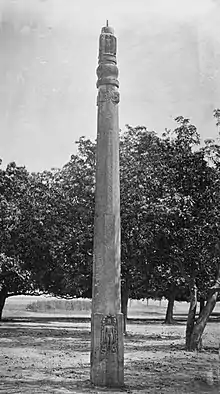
xmin=26 ymin=300 xmax=91 ymax=312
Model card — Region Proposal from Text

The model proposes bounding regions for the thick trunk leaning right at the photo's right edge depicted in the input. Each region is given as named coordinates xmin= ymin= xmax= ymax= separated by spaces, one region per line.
xmin=190 ymin=290 xmax=218 ymax=350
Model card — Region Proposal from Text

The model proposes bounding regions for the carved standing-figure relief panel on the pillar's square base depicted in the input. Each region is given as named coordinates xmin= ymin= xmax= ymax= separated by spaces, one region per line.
xmin=100 ymin=315 xmax=118 ymax=358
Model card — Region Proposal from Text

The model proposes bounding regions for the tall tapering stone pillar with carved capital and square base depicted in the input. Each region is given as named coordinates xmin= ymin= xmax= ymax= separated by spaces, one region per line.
xmin=91 ymin=24 xmax=124 ymax=387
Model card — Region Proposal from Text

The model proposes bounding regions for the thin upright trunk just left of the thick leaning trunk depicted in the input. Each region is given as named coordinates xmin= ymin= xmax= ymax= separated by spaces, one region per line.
xmin=186 ymin=279 xmax=197 ymax=350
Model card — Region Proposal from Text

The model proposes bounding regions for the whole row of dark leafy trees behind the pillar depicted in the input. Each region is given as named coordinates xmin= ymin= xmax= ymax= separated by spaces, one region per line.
xmin=0 ymin=110 xmax=220 ymax=350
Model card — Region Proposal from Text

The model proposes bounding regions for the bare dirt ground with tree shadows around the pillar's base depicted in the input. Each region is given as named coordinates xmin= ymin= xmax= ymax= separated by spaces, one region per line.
xmin=0 ymin=318 xmax=220 ymax=394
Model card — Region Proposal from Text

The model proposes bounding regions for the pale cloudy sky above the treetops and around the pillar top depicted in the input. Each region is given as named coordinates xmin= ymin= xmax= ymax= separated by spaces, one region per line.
xmin=0 ymin=0 xmax=220 ymax=171
